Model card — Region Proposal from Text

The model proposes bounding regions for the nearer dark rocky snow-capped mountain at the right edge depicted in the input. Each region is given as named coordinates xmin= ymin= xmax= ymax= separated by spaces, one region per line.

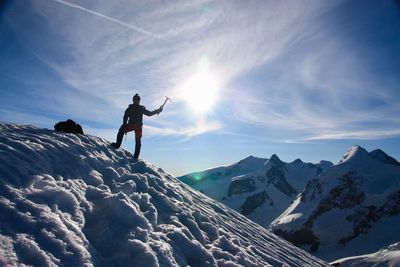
xmin=270 ymin=146 xmax=400 ymax=260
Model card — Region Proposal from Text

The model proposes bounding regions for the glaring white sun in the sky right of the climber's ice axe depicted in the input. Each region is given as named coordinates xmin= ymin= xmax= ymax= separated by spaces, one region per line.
xmin=180 ymin=69 xmax=219 ymax=114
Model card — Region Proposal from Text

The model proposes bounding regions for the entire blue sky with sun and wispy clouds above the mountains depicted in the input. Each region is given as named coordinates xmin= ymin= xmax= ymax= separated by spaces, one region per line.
xmin=0 ymin=0 xmax=400 ymax=175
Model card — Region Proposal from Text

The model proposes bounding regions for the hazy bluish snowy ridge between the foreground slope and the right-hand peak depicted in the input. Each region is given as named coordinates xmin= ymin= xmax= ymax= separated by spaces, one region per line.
xmin=179 ymin=154 xmax=332 ymax=227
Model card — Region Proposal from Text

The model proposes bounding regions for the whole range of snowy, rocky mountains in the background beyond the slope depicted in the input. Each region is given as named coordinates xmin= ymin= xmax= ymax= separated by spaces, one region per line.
xmin=180 ymin=146 xmax=400 ymax=261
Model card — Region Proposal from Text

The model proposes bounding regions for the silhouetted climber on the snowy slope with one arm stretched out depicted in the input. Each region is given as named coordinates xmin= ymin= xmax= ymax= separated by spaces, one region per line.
xmin=111 ymin=94 xmax=163 ymax=159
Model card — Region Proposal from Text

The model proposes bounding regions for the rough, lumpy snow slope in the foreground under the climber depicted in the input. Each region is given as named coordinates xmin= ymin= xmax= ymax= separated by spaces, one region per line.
xmin=0 ymin=124 xmax=327 ymax=267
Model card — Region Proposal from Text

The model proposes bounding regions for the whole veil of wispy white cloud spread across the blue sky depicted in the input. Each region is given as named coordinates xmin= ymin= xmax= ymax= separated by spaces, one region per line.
xmin=4 ymin=0 xmax=400 ymax=144
